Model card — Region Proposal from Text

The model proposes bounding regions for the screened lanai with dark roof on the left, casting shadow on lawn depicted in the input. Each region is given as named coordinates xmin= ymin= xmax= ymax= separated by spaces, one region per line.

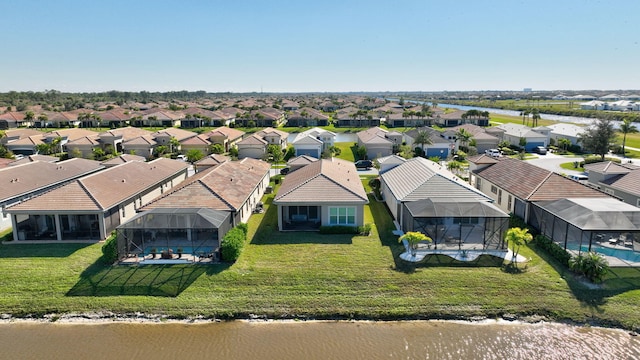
xmin=116 ymin=208 xmax=231 ymax=260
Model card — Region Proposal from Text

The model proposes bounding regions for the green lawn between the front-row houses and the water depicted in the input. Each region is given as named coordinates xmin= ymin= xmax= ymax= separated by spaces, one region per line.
xmin=0 ymin=180 xmax=640 ymax=328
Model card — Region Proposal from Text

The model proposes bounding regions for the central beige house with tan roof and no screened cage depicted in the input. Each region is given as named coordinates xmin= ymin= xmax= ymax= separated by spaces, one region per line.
xmin=273 ymin=158 xmax=369 ymax=231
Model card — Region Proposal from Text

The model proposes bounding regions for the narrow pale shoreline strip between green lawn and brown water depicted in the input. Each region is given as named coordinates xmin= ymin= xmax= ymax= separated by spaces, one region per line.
xmin=0 ymin=312 xmax=640 ymax=336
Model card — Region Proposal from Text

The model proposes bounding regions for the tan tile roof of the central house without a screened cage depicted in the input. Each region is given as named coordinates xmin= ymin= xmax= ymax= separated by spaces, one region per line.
xmin=274 ymin=158 xmax=368 ymax=204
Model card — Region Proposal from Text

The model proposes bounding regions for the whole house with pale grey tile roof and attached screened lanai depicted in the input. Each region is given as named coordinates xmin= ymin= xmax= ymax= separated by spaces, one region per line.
xmin=380 ymin=158 xmax=509 ymax=250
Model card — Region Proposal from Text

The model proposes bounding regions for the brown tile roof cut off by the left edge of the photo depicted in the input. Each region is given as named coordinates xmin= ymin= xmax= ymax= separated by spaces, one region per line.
xmin=0 ymin=158 xmax=103 ymax=204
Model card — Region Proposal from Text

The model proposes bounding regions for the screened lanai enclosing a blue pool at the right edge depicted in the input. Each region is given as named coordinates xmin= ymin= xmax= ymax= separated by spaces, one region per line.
xmin=529 ymin=198 xmax=640 ymax=266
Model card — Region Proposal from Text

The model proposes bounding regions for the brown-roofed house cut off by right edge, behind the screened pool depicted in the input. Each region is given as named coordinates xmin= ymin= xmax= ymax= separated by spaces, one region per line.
xmin=584 ymin=161 xmax=640 ymax=207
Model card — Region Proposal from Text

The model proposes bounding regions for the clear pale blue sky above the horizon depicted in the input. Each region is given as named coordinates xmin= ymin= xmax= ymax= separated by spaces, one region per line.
xmin=0 ymin=0 xmax=640 ymax=92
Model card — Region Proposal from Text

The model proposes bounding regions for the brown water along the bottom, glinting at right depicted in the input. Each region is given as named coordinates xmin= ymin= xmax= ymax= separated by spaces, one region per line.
xmin=0 ymin=321 xmax=640 ymax=360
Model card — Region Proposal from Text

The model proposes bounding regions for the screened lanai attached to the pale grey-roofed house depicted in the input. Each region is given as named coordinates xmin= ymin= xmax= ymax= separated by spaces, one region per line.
xmin=402 ymin=198 xmax=509 ymax=250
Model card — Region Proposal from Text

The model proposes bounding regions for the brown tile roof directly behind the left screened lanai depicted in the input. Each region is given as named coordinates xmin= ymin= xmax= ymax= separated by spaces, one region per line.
xmin=141 ymin=158 xmax=271 ymax=211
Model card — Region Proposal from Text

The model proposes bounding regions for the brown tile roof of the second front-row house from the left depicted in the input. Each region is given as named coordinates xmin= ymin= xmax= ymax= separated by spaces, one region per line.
xmin=7 ymin=158 xmax=188 ymax=212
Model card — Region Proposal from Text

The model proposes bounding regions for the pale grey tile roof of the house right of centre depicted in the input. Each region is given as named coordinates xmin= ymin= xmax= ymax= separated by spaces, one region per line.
xmin=380 ymin=158 xmax=490 ymax=201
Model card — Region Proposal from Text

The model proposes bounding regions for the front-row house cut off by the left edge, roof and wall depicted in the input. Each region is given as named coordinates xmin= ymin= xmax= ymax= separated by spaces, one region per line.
xmin=0 ymin=159 xmax=104 ymax=230
